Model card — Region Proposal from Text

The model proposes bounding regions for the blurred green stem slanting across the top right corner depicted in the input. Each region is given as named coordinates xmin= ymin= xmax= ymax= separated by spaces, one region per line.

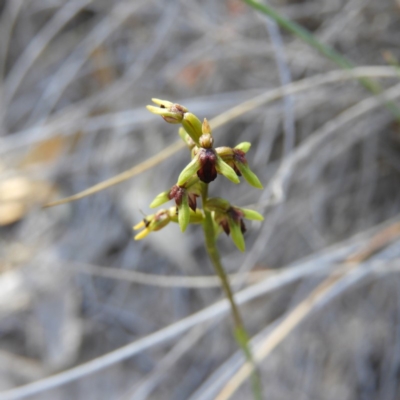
xmin=243 ymin=0 xmax=400 ymax=121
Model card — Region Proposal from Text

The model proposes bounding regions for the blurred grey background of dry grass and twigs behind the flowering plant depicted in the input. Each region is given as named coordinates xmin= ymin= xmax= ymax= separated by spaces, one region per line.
xmin=0 ymin=0 xmax=400 ymax=400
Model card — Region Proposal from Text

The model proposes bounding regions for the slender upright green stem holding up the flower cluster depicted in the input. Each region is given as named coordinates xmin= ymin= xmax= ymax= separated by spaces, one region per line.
xmin=203 ymin=185 xmax=262 ymax=400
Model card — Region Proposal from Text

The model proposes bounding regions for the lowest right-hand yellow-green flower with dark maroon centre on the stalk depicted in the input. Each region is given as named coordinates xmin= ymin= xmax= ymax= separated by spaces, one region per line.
xmin=206 ymin=197 xmax=264 ymax=251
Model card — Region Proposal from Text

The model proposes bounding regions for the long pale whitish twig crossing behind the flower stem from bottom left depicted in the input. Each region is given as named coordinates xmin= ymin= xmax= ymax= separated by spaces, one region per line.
xmin=0 ymin=216 xmax=393 ymax=400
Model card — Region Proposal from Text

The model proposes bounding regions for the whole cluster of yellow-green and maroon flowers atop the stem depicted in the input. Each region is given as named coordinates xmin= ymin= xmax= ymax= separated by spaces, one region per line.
xmin=134 ymin=99 xmax=263 ymax=251
